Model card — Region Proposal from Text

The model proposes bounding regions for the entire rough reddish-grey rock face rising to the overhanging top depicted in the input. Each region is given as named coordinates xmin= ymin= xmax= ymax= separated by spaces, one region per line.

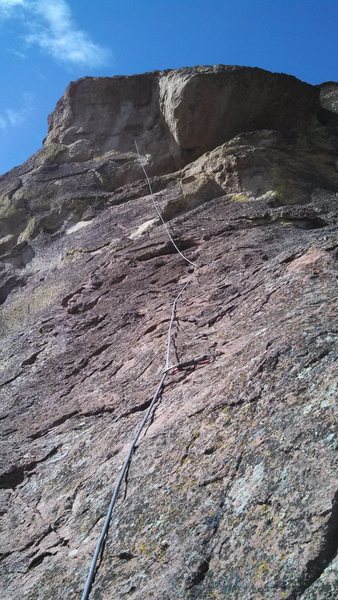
xmin=0 ymin=66 xmax=338 ymax=600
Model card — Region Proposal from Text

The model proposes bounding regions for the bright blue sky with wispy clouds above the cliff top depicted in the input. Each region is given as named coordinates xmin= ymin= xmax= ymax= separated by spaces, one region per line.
xmin=0 ymin=0 xmax=338 ymax=173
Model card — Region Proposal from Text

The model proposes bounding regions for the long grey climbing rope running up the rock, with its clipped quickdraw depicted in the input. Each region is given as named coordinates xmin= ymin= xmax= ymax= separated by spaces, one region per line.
xmin=81 ymin=140 xmax=209 ymax=600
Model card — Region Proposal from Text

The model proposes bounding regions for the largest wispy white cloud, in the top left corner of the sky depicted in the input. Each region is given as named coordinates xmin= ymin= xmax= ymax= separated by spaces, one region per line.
xmin=0 ymin=0 xmax=111 ymax=67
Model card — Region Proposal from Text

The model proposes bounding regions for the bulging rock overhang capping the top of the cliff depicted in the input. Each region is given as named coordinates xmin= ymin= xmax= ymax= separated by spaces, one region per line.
xmin=46 ymin=65 xmax=319 ymax=174
